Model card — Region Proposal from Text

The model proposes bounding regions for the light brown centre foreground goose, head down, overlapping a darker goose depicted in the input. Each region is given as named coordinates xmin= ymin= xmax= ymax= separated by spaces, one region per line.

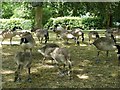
xmin=50 ymin=47 xmax=72 ymax=78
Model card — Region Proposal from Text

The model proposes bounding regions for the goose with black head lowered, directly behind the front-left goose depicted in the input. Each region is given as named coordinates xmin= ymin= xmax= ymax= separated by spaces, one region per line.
xmin=20 ymin=32 xmax=35 ymax=52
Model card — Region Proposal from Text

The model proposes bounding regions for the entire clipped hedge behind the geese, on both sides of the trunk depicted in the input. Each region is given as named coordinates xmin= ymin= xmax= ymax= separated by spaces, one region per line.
xmin=0 ymin=17 xmax=103 ymax=30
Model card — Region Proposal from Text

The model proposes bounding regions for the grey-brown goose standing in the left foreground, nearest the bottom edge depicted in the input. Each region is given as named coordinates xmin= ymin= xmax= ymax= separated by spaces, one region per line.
xmin=14 ymin=52 xmax=32 ymax=82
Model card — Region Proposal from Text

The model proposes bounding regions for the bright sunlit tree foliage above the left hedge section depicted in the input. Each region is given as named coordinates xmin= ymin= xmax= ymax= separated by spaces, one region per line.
xmin=2 ymin=2 xmax=31 ymax=19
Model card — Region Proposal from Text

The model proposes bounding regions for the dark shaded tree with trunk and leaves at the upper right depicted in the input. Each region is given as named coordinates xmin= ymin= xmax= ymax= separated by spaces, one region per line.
xmin=86 ymin=2 xmax=120 ymax=28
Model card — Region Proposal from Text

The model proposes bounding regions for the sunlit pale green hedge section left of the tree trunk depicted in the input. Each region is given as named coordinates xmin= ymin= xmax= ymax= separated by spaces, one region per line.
xmin=0 ymin=18 xmax=31 ymax=29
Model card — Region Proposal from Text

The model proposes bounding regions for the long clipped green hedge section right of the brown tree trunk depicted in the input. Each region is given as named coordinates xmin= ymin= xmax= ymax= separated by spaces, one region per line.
xmin=44 ymin=17 xmax=102 ymax=29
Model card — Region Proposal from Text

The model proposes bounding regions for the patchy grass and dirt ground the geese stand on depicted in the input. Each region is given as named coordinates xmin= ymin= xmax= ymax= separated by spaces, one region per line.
xmin=1 ymin=30 xmax=120 ymax=88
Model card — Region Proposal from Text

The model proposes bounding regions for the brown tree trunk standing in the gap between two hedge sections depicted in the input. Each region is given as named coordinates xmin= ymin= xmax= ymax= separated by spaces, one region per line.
xmin=35 ymin=6 xmax=43 ymax=28
